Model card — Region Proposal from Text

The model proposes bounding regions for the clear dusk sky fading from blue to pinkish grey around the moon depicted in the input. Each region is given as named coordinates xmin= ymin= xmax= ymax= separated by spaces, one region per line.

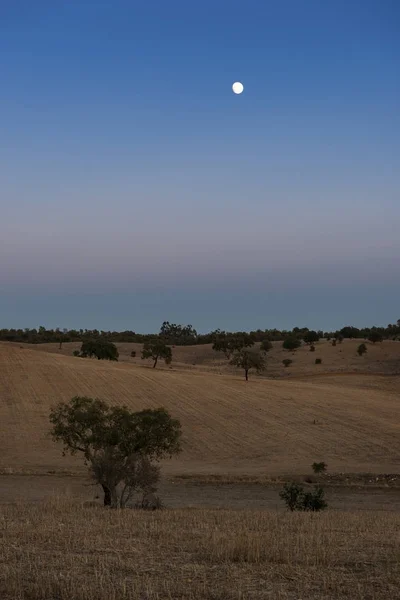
xmin=0 ymin=0 xmax=400 ymax=333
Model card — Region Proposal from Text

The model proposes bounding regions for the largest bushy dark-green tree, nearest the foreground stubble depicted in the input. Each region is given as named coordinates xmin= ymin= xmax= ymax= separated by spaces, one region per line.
xmin=50 ymin=396 xmax=181 ymax=508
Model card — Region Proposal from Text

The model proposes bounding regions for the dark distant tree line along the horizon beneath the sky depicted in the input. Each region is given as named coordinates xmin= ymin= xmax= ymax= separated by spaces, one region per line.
xmin=0 ymin=319 xmax=400 ymax=351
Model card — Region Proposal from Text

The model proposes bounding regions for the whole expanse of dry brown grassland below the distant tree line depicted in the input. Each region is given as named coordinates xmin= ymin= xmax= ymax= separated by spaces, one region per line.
xmin=0 ymin=341 xmax=400 ymax=600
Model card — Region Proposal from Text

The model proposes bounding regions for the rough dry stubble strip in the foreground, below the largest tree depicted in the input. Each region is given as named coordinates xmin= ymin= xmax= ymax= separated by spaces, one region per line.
xmin=0 ymin=498 xmax=400 ymax=600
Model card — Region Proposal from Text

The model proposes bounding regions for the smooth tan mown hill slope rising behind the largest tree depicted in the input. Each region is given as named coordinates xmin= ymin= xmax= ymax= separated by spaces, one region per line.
xmin=0 ymin=343 xmax=400 ymax=474
